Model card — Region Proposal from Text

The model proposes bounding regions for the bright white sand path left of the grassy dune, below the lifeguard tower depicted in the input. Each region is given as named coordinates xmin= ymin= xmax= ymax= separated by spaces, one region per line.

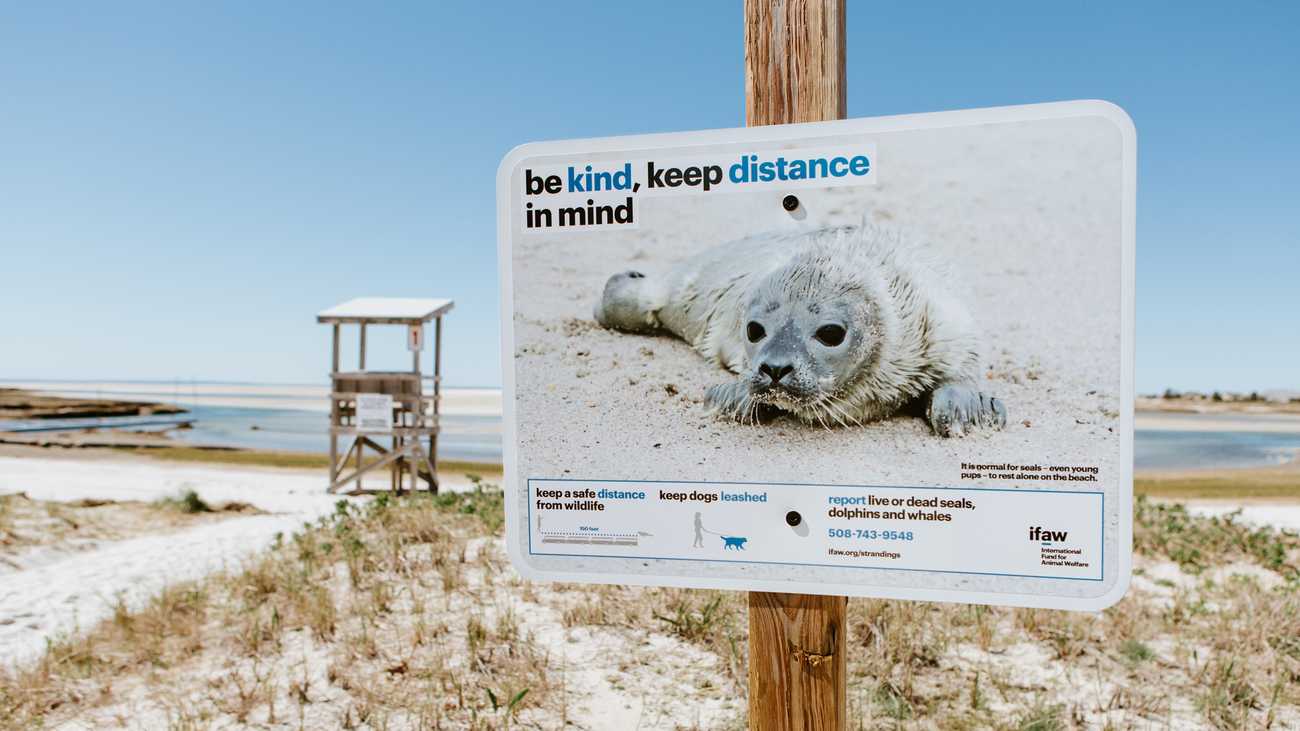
xmin=0 ymin=457 xmax=355 ymax=663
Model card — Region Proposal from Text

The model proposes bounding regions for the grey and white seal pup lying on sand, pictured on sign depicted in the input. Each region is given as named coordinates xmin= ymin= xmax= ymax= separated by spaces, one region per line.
xmin=594 ymin=225 xmax=1006 ymax=437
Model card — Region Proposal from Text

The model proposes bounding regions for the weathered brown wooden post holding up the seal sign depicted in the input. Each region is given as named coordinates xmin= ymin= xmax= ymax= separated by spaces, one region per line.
xmin=745 ymin=0 xmax=848 ymax=731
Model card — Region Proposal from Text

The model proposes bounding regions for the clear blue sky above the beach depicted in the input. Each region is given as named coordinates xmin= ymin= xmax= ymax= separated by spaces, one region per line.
xmin=0 ymin=0 xmax=1300 ymax=392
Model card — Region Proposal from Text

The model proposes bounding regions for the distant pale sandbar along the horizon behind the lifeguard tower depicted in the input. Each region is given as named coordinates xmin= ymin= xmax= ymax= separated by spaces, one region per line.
xmin=0 ymin=381 xmax=501 ymax=416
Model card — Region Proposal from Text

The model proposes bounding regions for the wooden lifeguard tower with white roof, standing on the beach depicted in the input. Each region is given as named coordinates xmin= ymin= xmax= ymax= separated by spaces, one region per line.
xmin=316 ymin=297 xmax=452 ymax=493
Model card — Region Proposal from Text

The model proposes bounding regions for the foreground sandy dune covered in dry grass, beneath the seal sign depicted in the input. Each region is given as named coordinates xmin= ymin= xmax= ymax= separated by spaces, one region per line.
xmin=10 ymin=484 xmax=1300 ymax=731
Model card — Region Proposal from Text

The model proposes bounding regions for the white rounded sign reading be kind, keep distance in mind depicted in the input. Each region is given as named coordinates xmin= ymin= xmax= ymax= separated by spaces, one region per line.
xmin=498 ymin=101 xmax=1135 ymax=610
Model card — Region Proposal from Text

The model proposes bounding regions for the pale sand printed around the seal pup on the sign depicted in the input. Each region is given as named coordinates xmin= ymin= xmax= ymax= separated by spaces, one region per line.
xmin=512 ymin=117 xmax=1122 ymax=593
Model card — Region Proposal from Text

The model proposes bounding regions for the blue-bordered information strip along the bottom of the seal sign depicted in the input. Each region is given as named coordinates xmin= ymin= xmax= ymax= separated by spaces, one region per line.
xmin=528 ymin=480 xmax=1105 ymax=581
